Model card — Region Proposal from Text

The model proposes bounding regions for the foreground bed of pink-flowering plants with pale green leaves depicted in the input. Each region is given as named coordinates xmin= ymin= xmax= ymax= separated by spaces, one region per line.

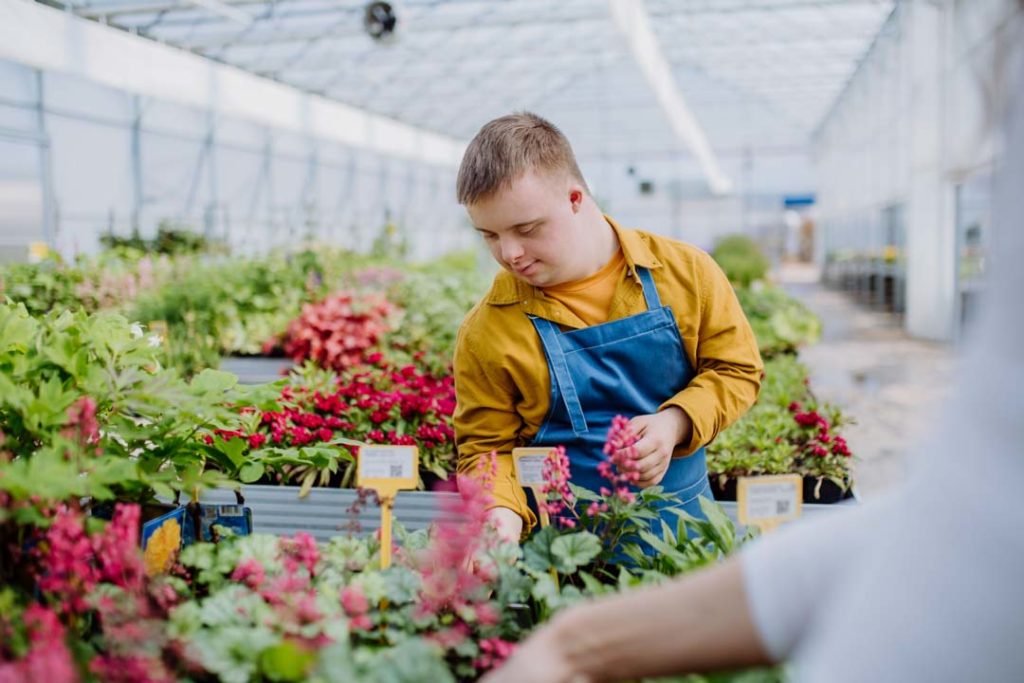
xmin=0 ymin=395 xmax=778 ymax=683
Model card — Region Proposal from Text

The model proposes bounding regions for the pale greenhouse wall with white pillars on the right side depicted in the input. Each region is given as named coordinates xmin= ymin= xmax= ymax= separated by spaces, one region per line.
xmin=815 ymin=0 xmax=1021 ymax=340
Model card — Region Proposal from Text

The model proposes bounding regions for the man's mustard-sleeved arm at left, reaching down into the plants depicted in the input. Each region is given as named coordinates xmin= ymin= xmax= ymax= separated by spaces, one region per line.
xmin=453 ymin=328 xmax=537 ymax=541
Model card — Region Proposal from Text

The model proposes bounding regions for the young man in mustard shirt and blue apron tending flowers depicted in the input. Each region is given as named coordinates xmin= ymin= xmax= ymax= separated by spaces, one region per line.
xmin=455 ymin=114 xmax=762 ymax=539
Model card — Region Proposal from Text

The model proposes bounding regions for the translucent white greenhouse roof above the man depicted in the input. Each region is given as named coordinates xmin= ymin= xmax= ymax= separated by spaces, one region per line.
xmin=41 ymin=0 xmax=895 ymax=183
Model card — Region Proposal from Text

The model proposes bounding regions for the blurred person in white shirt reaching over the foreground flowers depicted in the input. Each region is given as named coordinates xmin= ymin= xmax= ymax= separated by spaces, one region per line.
xmin=484 ymin=9 xmax=1024 ymax=683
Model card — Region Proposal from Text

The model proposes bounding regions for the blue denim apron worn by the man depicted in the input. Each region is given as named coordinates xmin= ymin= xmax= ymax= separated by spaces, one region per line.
xmin=529 ymin=267 xmax=712 ymax=536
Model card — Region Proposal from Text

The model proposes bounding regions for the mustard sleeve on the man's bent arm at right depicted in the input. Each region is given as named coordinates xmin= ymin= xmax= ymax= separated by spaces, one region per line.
xmin=658 ymin=253 xmax=764 ymax=455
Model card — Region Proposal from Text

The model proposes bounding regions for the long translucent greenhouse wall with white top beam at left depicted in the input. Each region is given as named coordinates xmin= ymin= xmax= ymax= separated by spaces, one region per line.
xmin=0 ymin=3 xmax=472 ymax=260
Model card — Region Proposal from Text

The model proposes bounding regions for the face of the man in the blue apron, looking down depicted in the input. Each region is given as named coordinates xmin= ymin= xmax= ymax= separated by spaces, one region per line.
xmin=466 ymin=171 xmax=590 ymax=287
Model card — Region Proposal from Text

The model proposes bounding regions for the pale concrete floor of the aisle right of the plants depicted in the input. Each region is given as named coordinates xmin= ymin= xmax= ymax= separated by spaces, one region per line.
xmin=774 ymin=264 xmax=955 ymax=500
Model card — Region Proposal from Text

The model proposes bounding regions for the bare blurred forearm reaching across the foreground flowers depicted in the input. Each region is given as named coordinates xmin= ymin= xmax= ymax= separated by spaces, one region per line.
xmin=483 ymin=558 xmax=770 ymax=683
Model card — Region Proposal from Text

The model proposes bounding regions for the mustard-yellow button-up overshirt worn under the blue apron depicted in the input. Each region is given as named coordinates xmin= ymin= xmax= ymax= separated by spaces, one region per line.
xmin=454 ymin=218 xmax=763 ymax=527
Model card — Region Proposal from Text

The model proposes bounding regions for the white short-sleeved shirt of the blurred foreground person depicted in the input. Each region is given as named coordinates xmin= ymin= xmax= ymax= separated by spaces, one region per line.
xmin=741 ymin=25 xmax=1024 ymax=683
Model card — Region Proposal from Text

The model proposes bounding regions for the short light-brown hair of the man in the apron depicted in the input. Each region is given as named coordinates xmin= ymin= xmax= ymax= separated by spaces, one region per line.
xmin=456 ymin=112 xmax=590 ymax=204
